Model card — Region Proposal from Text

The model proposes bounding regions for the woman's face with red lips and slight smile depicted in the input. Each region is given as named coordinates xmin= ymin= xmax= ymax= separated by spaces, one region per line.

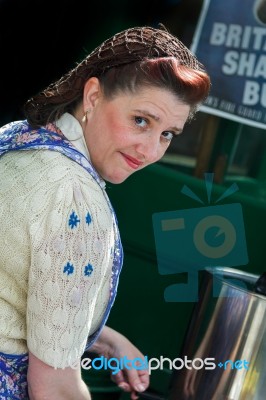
xmin=84 ymin=87 xmax=190 ymax=183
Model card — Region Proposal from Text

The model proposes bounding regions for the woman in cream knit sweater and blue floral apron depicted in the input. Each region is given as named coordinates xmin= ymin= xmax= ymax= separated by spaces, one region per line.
xmin=0 ymin=27 xmax=210 ymax=400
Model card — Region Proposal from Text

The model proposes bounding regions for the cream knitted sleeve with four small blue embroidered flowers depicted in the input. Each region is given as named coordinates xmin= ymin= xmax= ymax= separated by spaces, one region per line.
xmin=27 ymin=153 xmax=114 ymax=368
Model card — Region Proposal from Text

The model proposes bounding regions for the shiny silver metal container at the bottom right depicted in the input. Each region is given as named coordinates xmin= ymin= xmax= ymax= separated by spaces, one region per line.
xmin=169 ymin=268 xmax=266 ymax=400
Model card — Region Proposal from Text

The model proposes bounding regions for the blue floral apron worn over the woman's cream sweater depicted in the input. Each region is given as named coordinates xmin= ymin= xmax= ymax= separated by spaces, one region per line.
xmin=0 ymin=120 xmax=123 ymax=400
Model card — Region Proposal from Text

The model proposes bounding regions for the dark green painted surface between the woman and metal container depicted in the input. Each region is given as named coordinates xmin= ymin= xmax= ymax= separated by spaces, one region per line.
xmin=83 ymin=164 xmax=266 ymax=399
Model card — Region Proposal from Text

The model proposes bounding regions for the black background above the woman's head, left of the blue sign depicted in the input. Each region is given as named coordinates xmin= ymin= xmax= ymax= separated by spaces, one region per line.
xmin=0 ymin=0 xmax=202 ymax=125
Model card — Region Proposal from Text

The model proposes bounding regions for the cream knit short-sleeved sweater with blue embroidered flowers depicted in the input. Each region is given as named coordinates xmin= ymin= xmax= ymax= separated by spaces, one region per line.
xmin=0 ymin=116 xmax=114 ymax=368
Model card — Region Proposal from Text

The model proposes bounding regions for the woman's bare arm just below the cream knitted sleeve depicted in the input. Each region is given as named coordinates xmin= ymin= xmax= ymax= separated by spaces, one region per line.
xmin=28 ymin=352 xmax=91 ymax=400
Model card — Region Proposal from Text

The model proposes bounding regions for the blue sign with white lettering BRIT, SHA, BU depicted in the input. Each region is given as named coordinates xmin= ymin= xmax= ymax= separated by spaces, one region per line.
xmin=191 ymin=0 xmax=266 ymax=128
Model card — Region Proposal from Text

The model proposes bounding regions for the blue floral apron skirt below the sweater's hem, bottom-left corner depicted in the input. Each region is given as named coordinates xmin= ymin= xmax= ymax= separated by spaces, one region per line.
xmin=0 ymin=353 xmax=29 ymax=400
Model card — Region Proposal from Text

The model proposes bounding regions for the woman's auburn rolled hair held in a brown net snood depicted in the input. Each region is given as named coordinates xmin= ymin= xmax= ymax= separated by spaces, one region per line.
xmin=24 ymin=27 xmax=210 ymax=128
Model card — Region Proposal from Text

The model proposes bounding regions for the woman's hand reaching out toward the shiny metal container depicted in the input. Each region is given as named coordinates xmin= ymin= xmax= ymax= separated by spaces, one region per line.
xmin=89 ymin=326 xmax=149 ymax=400
